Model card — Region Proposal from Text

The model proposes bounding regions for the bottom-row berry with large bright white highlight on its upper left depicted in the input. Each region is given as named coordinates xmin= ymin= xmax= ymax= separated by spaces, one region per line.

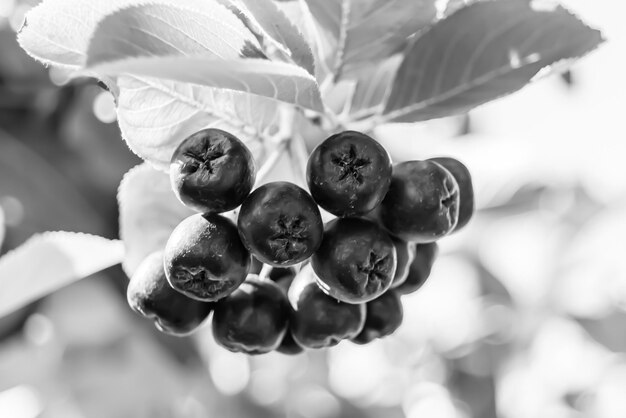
xmin=289 ymin=265 xmax=365 ymax=348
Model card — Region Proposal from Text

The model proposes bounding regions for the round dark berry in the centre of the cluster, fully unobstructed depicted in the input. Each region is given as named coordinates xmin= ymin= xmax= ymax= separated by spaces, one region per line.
xmin=237 ymin=182 xmax=324 ymax=266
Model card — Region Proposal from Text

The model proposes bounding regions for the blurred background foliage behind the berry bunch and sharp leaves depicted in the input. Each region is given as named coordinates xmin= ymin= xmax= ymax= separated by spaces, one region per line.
xmin=0 ymin=0 xmax=626 ymax=418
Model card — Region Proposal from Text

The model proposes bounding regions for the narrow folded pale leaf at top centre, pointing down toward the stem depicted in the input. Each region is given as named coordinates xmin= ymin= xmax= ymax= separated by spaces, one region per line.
xmin=234 ymin=0 xmax=315 ymax=75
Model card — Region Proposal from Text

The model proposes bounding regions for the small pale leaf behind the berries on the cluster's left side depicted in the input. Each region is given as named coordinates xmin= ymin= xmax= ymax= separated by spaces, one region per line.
xmin=117 ymin=163 xmax=194 ymax=277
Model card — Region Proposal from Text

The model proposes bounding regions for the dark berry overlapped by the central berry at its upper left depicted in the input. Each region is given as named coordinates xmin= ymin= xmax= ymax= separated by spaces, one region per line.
xmin=311 ymin=218 xmax=397 ymax=303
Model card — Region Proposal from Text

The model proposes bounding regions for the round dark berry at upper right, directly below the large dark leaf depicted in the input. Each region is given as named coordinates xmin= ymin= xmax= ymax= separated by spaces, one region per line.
xmin=306 ymin=131 xmax=391 ymax=216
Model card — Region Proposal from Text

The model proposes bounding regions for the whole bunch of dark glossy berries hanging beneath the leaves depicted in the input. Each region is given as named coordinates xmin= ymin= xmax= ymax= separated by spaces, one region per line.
xmin=127 ymin=129 xmax=474 ymax=354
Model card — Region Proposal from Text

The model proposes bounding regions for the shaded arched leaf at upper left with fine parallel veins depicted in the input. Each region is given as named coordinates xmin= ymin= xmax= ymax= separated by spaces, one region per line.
xmin=86 ymin=0 xmax=264 ymax=67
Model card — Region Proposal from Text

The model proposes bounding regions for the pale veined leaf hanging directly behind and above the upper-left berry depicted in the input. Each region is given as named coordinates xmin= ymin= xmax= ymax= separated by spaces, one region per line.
xmin=117 ymin=76 xmax=279 ymax=170
